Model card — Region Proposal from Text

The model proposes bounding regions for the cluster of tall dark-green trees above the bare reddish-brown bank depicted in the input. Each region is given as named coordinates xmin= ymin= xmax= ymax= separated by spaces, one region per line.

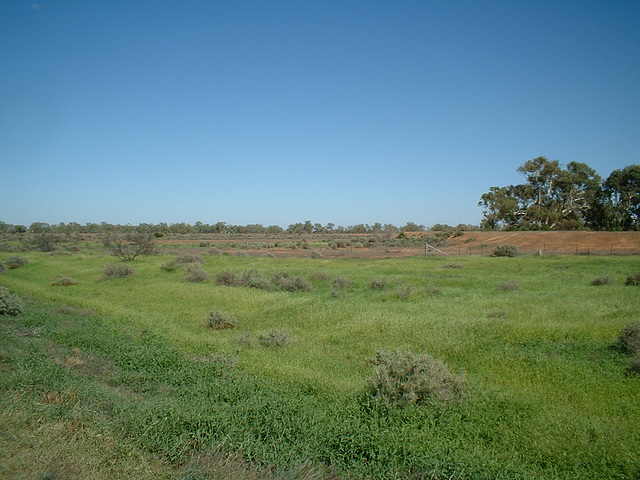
xmin=478 ymin=157 xmax=640 ymax=231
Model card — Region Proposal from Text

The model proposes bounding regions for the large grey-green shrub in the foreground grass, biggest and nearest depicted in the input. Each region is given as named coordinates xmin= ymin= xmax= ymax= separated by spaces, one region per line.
xmin=368 ymin=350 xmax=465 ymax=407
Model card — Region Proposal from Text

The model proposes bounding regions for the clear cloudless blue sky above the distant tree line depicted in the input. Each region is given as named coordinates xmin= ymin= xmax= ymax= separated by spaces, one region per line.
xmin=0 ymin=0 xmax=640 ymax=227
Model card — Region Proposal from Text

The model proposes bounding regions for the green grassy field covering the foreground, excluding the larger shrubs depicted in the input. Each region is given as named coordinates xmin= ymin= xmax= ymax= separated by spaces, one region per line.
xmin=0 ymin=252 xmax=640 ymax=480
